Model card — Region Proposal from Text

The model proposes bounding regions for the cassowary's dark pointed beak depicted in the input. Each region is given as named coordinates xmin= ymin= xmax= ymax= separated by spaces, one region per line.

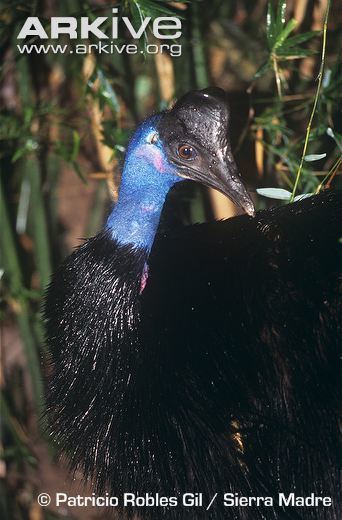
xmin=182 ymin=158 xmax=255 ymax=217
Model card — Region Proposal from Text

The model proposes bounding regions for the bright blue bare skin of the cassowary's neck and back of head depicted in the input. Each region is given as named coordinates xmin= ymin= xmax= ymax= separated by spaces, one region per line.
xmin=106 ymin=116 xmax=182 ymax=252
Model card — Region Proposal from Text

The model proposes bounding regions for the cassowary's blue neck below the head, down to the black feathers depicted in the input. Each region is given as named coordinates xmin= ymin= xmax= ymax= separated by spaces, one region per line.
xmin=106 ymin=161 xmax=171 ymax=252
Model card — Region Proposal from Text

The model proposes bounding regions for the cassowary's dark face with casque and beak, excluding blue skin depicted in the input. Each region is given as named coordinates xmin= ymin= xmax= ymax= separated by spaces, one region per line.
xmin=158 ymin=88 xmax=254 ymax=215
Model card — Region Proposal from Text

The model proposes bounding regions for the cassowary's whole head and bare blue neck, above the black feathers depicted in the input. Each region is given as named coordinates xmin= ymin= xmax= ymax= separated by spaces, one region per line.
xmin=106 ymin=88 xmax=254 ymax=250
